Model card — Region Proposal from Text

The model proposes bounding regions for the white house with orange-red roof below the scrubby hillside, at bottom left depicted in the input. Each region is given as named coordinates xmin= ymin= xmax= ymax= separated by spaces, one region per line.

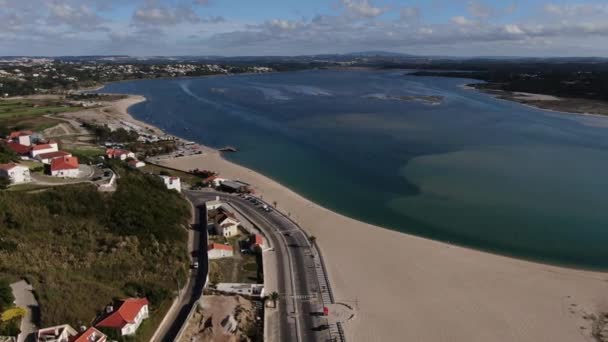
xmin=95 ymin=298 xmax=149 ymax=336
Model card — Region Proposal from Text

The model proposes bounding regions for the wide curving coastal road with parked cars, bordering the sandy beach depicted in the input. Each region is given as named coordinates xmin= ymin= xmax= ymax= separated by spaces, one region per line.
xmin=185 ymin=191 xmax=338 ymax=342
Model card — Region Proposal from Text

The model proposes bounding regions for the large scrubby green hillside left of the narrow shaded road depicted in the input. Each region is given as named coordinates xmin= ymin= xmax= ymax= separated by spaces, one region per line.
xmin=0 ymin=166 xmax=190 ymax=326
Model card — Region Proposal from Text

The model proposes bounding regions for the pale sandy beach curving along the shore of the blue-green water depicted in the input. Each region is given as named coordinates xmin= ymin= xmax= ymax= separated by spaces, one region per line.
xmin=76 ymin=97 xmax=608 ymax=342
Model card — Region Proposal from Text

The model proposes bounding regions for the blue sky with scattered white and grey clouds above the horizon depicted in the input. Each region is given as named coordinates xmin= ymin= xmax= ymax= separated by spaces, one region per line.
xmin=0 ymin=0 xmax=608 ymax=57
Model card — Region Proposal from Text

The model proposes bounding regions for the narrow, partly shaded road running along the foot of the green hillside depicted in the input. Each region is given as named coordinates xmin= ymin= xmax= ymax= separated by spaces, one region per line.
xmin=153 ymin=203 xmax=207 ymax=342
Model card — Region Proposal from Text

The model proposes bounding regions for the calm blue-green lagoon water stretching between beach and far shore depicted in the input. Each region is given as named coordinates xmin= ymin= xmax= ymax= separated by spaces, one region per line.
xmin=104 ymin=71 xmax=608 ymax=269
